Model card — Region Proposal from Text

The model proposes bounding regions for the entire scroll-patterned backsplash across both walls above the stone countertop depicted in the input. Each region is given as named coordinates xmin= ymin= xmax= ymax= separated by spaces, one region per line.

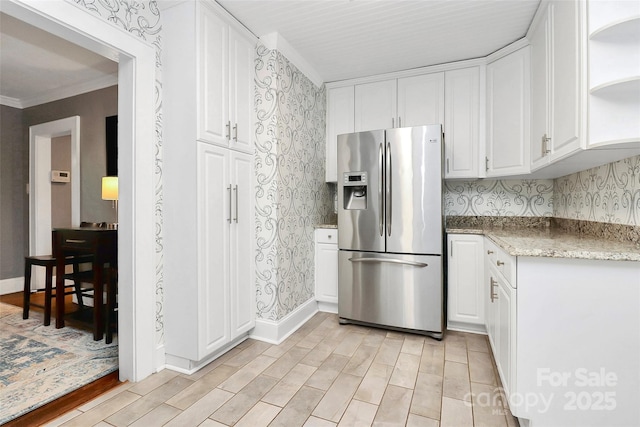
xmin=444 ymin=156 xmax=640 ymax=226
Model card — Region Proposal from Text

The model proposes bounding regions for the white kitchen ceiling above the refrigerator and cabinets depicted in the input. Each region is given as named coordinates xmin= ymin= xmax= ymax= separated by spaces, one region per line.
xmin=217 ymin=0 xmax=540 ymax=82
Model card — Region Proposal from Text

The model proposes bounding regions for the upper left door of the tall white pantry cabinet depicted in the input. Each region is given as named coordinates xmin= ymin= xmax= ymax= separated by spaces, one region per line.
xmin=201 ymin=6 xmax=229 ymax=146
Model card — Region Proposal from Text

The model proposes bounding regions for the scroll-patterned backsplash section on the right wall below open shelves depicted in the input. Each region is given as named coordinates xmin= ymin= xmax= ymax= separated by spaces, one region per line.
xmin=553 ymin=156 xmax=640 ymax=226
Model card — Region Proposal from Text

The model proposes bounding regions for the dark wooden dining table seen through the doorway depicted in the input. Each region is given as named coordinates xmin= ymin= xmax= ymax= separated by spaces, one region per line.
xmin=52 ymin=227 xmax=118 ymax=341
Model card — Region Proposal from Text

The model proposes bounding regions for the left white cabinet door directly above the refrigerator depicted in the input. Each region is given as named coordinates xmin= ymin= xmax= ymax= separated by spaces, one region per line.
xmin=354 ymin=79 xmax=397 ymax=132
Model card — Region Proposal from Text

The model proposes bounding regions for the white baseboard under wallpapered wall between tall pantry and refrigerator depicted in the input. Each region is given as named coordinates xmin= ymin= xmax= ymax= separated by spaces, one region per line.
xmin=249 ymin=298 xmax=318 ymax=345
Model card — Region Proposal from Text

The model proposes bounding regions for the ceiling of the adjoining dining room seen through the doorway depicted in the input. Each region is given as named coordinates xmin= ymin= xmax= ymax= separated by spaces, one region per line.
xmin=0 ymin=12 xmax=118 ymax=108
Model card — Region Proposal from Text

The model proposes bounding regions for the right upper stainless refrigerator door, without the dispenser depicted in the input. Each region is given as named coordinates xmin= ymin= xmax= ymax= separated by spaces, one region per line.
xmin=382 ymin=125 xmax=442 ymax=255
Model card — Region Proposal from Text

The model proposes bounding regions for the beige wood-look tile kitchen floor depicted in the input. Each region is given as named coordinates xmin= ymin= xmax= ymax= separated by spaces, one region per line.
xmin=48 ymin=313 xmax=518 ymax=427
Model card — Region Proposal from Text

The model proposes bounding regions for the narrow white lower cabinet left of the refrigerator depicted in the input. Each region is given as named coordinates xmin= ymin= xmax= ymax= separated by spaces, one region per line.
xmin=315 ymin=228 xmax=338 ymax=313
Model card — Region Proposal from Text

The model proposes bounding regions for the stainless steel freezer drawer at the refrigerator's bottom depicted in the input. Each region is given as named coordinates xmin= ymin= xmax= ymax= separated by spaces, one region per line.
xmin=338 ymin=250 xmax=444 ymax=333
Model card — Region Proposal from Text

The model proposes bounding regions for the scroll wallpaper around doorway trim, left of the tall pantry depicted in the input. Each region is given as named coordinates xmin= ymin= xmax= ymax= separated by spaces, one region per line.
xmin=72 ymin=0 xmax=164 ymax=344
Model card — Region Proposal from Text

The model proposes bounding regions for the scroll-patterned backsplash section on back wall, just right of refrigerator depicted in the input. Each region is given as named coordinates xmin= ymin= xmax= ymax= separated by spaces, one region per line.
xmin=444 ymin=179 xmax=553 ymax=216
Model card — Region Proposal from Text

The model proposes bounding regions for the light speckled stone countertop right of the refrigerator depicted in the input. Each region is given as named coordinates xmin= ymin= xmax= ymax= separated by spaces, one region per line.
xmin=447 ymin=228 xmax=640 ymax=261
